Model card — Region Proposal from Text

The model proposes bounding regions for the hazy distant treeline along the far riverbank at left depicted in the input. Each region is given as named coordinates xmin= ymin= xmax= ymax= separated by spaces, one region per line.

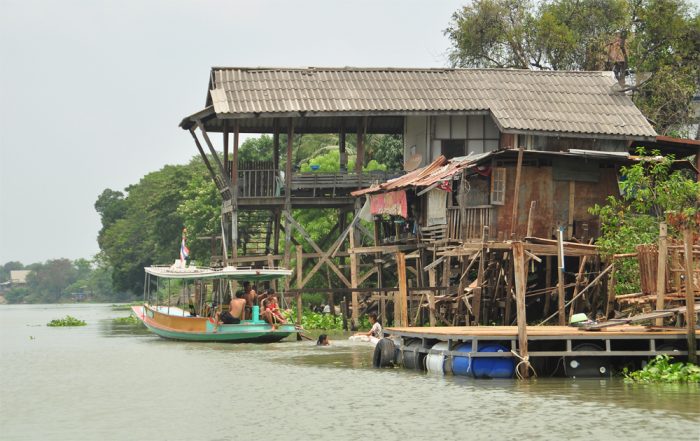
xmin=0 ymin=258 xmax=132 ymax=303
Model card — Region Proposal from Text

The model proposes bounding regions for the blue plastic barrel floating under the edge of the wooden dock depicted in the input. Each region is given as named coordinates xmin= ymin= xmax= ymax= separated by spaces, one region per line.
xmin=452 ymin=343 xmax=515 ymax=378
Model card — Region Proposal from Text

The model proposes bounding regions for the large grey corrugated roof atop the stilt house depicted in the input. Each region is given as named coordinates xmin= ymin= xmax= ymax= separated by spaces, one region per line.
xmin=207 ymin=67 xmax=656 ymax=137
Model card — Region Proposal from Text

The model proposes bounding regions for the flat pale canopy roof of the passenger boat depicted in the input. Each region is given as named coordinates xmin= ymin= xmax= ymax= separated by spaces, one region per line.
xmin=144 ymin=265 xmax=292 ymax=281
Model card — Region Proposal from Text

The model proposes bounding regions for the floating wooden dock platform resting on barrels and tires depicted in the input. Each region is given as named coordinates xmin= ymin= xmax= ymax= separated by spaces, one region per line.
xmin=384 ymin=325 xmax=700 ymax=377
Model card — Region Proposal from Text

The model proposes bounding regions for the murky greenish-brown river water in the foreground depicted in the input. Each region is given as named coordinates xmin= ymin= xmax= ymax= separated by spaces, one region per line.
xmin=0 ymin=305 xmax=700 ymax=441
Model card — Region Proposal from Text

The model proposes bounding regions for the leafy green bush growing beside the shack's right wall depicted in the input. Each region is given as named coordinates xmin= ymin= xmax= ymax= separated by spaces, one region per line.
xmin=589 ymin=149 xmax=700 ymax=294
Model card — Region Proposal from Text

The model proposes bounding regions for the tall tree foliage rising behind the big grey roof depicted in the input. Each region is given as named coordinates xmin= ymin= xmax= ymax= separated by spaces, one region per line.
xmin=445 ymin=0 xmax=700 ymax=136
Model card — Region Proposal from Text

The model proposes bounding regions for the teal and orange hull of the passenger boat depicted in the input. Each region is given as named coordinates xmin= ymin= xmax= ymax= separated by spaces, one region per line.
xmin=132 ymin=306 xmax=299 ymax=343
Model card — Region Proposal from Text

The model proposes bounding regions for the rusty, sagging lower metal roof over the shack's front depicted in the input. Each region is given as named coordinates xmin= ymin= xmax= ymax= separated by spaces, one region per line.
xmin=351 ymin=149 xmax=632 ymax=197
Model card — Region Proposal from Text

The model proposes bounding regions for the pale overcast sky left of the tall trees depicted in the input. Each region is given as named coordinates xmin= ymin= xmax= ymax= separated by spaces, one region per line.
xmin=0 ymin=0 xmax=465 ymax=265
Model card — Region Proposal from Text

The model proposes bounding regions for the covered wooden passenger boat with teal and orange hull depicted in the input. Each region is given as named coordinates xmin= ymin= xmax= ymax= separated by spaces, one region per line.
xmin=132 ymin=261 xmax=302 ymax=343
